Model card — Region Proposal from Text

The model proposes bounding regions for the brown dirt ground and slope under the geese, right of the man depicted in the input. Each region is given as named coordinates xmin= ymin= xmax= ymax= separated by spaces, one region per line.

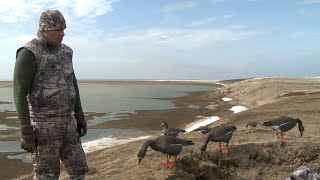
xmin=0 ymin=77 xmax=320 ymax=180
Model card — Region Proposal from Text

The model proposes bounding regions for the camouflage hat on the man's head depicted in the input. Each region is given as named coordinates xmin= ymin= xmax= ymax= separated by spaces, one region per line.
xmin=39 ymin=10 xmax=66 ymax=31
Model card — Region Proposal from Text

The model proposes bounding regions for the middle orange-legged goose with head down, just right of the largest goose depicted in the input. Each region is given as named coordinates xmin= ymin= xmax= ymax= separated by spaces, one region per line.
xmin=200 ymin=125 xmax=237 ymax=157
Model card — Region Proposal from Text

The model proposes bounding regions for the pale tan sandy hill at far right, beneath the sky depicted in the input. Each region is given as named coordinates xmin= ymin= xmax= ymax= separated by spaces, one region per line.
xmin=219 ymin=77 xmax=320 ymax=107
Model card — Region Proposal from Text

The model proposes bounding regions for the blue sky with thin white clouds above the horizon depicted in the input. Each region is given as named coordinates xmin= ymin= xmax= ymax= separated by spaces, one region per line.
xmin=0 ymin=0 xmax=320 ymax=80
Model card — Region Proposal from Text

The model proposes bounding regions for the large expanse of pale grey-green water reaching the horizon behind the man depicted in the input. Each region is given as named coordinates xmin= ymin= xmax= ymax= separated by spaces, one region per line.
xmin=0 ymin=84 xmax=218 ymax=113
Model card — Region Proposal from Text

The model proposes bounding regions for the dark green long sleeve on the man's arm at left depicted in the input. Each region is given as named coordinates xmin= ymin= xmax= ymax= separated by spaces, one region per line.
xmin=13 ymin=48 xmax=36 ymax=125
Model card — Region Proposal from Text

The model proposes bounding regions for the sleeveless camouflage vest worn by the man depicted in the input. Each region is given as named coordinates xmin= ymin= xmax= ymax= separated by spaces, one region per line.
xmin=24 ymin=39 xmax=76 ymax=117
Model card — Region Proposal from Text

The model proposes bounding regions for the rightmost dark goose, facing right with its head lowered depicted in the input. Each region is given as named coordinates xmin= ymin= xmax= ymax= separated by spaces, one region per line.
xmin=261 ymin=116 xmax=304 ymax=142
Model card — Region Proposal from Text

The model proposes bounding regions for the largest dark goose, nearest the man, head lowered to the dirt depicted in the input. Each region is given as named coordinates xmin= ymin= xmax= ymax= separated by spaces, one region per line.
xmin=138 ymin=136 xmax=194 ymax=168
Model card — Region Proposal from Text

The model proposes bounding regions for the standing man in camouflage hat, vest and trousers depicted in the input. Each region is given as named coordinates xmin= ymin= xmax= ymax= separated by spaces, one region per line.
xmin=13 ymin=10 xmax=88 ymax=180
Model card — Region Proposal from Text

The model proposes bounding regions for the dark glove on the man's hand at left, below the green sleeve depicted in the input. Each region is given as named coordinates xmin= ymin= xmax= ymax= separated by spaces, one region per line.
xmin=20 ymin=125 xmax=38 ymax=153
